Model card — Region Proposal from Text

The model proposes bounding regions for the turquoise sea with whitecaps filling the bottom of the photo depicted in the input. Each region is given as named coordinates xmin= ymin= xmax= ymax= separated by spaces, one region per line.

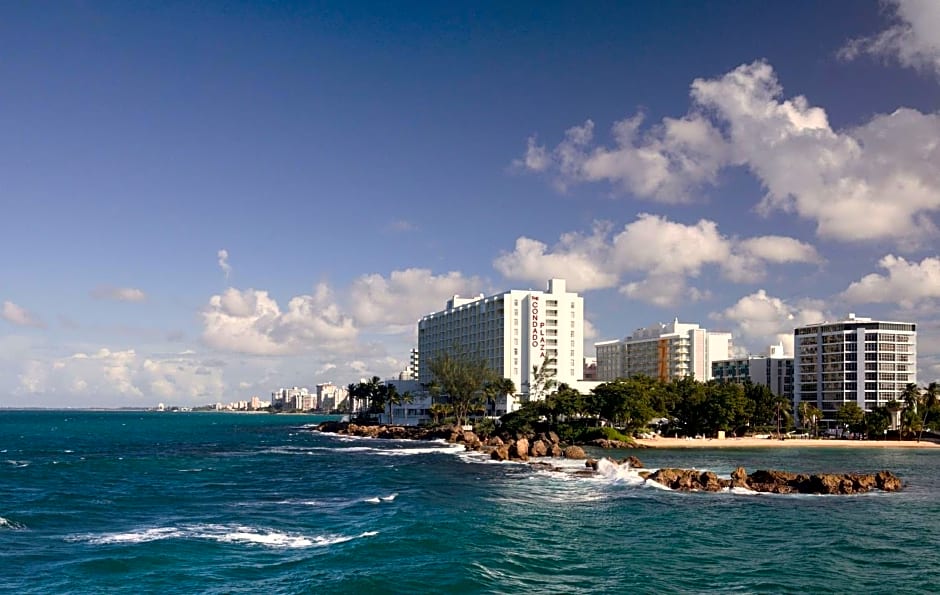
xmin=0 ymin=411 xmax=940 ymax=594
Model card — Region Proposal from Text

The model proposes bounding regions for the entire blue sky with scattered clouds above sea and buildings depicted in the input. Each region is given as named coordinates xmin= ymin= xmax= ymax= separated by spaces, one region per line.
xmin=0 ymin=0 xmax=940 ymax=407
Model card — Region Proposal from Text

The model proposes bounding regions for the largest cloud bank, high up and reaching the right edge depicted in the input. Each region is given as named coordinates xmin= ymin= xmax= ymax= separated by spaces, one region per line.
xmin=517 ymin=61 xmax=940 ymax=249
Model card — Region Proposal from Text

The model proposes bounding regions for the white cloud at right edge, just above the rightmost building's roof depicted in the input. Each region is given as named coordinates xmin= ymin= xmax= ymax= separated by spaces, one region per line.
xmin=841 ymin=254 xmax=940 ymax=308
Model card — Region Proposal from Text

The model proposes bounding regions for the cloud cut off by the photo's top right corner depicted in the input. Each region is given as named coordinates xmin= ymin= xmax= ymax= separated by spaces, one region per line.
xmin=839 ymin=0 xmax=940 ymax=76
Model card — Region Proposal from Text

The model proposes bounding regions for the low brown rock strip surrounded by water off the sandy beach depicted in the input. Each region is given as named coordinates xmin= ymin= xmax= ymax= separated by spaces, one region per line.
xmin=640 ymin=467 xmax=903 ymax=495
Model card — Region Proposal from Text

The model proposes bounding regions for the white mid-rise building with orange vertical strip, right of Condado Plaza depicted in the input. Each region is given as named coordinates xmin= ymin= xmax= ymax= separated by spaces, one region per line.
xmin=594 ymin=318 xmax=732 ymax=382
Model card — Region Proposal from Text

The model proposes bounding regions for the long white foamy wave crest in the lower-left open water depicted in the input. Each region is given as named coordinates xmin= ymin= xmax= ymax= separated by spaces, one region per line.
xmin=68 ymin=525 xmax=378 ymax=549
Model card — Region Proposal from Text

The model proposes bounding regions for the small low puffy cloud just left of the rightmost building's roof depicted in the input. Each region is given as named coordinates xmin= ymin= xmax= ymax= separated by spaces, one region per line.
xmin=711 ymin=289 xmax=827 ymax=355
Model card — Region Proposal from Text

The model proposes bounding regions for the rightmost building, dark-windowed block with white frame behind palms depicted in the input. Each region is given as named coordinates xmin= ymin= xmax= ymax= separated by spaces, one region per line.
xmin=793 ymin=314 xmax=917 ymax=425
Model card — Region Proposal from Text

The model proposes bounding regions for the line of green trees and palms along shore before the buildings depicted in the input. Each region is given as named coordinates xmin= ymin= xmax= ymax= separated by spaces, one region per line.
xmin=349 ymin=353 xmax=940 ymax=438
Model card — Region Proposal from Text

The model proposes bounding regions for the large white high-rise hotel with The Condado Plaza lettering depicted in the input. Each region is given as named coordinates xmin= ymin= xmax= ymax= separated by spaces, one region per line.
xmin=418 ymin=279 xmax=584 ymax=394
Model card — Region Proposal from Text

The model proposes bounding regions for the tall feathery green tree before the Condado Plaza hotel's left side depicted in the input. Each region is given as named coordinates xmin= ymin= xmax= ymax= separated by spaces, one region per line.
xmin=428 ymin=353 xmax=498 ymax=426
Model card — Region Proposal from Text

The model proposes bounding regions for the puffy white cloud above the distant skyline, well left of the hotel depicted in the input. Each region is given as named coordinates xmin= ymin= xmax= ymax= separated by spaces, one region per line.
xmin=202 ymin=284 xmax=358 ymax=355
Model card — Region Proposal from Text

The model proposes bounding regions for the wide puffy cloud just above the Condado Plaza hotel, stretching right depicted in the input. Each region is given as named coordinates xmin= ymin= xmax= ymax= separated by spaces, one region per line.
xmin=493 ymin=213 xmax=822 ymax=306
